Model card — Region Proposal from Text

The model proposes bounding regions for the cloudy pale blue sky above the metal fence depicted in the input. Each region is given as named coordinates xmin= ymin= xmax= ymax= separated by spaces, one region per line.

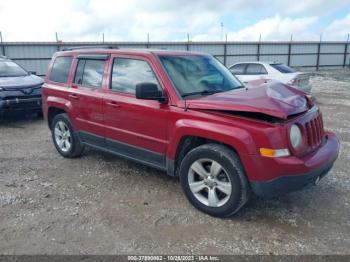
xmin=0 ymin=0 xmax=350 ymax=41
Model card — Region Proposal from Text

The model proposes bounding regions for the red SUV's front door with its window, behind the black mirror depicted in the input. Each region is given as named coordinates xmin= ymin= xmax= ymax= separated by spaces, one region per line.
xmin=103 ymin=56 xmax=169 ymax=167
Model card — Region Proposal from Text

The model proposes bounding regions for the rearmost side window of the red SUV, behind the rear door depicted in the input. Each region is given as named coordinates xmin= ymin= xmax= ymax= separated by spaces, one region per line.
xmin=50 ymin=56 xmax=73 ymax=84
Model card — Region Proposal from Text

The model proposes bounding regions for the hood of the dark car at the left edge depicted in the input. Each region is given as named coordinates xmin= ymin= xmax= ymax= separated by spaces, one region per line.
xmin=0 ymin=75 xmax=44 ymax=90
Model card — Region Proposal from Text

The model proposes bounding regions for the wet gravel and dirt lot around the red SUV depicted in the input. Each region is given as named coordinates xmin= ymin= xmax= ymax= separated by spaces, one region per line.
xmin=0 ymin=71 xmax=350 ymax=254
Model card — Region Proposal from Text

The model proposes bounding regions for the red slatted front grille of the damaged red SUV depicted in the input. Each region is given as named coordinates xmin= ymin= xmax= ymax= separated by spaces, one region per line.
xmin=305 ymin=114 xmax=324 ymax=149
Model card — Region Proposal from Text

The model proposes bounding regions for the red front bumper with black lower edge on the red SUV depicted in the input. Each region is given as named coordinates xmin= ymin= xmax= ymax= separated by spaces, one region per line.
xmin=250 ymin=133 xmax=340 ymax=198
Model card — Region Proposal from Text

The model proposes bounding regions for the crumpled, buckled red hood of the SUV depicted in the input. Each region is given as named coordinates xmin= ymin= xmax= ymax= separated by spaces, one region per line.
xmin=185 ymin=81 xmax=309 ymax=119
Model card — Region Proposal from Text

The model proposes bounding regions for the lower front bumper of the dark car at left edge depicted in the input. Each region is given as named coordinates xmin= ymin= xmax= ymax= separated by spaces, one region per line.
xmin=0 ymin=97 xmax=42 ymax=114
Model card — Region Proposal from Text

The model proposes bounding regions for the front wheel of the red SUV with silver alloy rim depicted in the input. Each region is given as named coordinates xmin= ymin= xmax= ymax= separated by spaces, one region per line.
xmin=180 ymin=144 xmax=250 ymax=217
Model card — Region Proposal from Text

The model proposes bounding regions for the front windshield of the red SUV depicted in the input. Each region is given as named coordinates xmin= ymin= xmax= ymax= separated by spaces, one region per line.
xmin=159 ymin=55 xmax=242 ymax=97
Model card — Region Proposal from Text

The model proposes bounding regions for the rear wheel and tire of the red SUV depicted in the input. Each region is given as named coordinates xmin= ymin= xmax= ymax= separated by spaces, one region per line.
xmin=51 ymin=114 xmax=84 ymax=158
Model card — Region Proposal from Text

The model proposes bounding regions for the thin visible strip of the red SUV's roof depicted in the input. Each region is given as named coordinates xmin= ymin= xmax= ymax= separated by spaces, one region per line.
xmin=57 ymin=48 xmax=207 ymax=55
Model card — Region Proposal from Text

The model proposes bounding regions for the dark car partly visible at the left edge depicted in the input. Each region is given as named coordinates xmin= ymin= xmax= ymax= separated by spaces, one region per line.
xmin=0 ymin=56 xmax=43 ymax=117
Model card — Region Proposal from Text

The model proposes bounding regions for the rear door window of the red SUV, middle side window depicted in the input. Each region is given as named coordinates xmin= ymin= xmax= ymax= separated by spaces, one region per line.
xmin=74 ymin=59 xmax=106 ymax=88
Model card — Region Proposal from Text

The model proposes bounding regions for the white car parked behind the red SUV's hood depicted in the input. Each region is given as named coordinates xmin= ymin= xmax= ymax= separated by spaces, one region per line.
xmin=229 ymin=61 xmax=312 ymax=93
